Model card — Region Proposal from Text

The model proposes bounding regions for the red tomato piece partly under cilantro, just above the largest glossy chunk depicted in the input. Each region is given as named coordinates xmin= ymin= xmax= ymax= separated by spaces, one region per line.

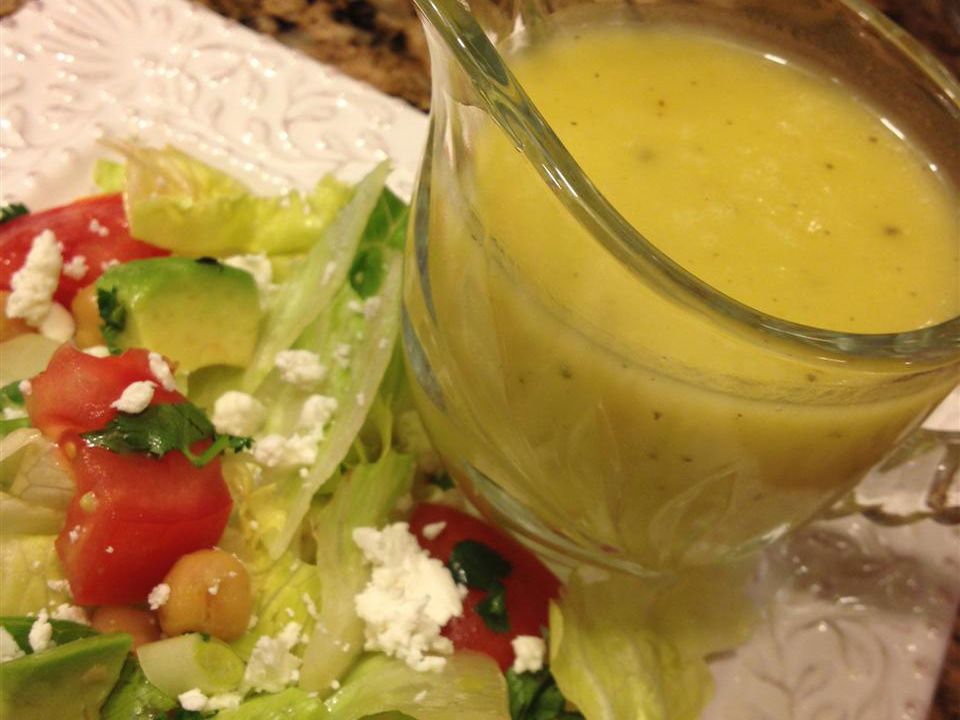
xmin=26 ymin=344 xmax=184 ymax=441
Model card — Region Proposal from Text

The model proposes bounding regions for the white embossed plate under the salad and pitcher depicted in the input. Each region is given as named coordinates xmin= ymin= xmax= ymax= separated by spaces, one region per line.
xmin=0 ymin=0 xmax=960 ymax=720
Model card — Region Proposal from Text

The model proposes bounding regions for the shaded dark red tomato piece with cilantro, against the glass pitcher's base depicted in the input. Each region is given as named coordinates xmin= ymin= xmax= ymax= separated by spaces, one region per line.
xmin=410 ymin=503 xmax=560 ymax=671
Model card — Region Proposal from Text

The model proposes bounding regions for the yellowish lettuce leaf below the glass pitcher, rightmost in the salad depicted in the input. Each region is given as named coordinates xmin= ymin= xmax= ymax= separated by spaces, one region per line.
xmin=550 ymin=565 xmax=755 ymax=720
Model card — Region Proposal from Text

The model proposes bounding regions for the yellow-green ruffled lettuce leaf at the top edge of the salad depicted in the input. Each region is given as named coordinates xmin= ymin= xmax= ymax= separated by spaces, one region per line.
xmin=110 ymin=143 xmax=352 ymax=256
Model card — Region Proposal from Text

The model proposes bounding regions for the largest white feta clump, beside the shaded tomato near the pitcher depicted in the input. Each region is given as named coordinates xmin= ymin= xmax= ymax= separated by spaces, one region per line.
xmin=353 ymin=523 xmax=466 ymax=671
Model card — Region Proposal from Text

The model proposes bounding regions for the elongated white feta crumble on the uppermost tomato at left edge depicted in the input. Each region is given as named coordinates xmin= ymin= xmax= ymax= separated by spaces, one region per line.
xmin=5 ymin=230 xmax=63 ymax=327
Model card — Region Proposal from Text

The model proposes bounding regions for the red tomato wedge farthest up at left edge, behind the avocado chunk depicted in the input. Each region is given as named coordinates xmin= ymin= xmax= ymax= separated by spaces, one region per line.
xmin=0 ymin=194 xmax=170 ymax=308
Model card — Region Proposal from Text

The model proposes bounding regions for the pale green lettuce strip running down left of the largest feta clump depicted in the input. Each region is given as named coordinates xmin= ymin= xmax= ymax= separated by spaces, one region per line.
xmin=300 ymin=451 xmax=413 ymax=692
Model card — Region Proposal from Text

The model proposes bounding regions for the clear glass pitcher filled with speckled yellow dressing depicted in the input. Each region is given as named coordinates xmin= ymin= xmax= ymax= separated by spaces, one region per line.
xmin=403 ymin=0 xmax=960 ymax=573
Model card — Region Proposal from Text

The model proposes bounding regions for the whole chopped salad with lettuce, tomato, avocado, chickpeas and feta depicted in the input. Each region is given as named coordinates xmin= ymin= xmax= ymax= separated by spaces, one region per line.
xmin=0 ymin=144 xmax=750 ymax=720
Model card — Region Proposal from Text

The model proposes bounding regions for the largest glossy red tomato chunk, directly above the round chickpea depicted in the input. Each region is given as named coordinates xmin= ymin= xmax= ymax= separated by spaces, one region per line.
xmin=56 ymin=433 xmax=232 ymax=605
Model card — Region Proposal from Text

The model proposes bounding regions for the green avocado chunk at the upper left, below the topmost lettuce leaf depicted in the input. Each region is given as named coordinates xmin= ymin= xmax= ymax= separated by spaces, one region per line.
xmin=97 ymin=257 xmax=260 ymax=372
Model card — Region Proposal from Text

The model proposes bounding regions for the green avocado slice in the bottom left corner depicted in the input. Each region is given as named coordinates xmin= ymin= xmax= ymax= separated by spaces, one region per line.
xmin=0 ymin=633 xmax=132 ymax=720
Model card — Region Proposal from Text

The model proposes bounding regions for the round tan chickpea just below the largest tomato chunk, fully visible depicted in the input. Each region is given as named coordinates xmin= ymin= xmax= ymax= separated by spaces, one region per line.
xmin=159 ymin=548 xmax=253 ymax=642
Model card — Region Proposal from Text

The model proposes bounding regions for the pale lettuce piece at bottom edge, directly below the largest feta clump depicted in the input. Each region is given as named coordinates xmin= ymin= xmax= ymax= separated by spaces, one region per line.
xmin=325 ymin=653 xmax=510 ymax=720
